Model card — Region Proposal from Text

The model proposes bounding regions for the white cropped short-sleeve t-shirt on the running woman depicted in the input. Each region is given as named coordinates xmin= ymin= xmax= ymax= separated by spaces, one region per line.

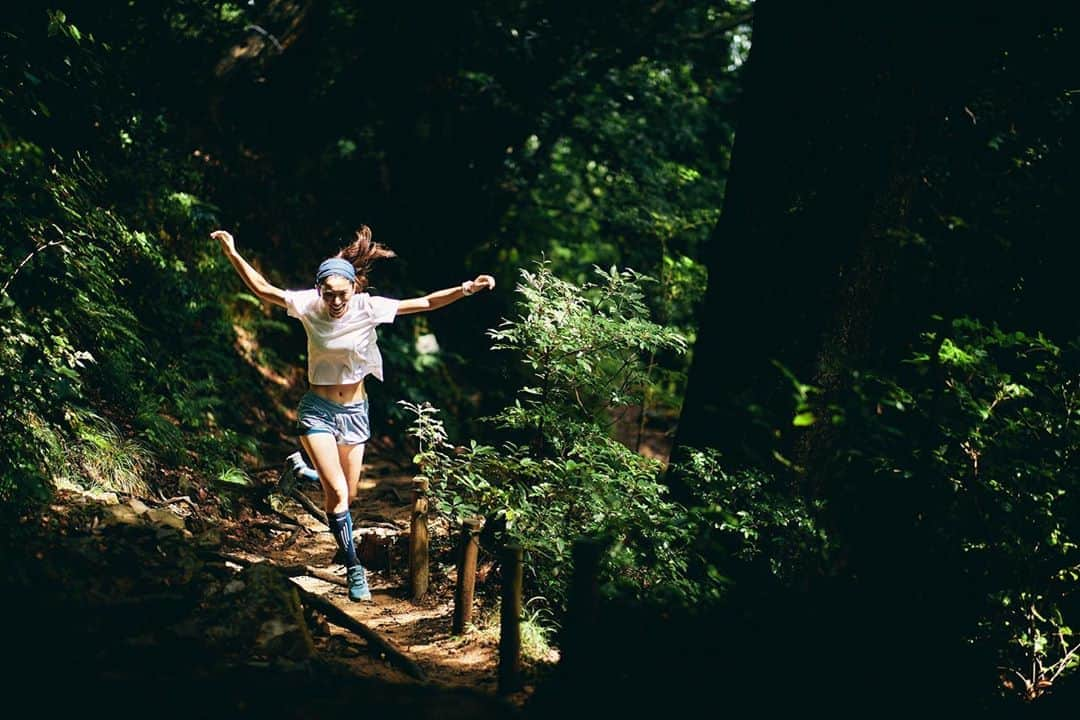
xmin=285 ymin=289 xmax=401 ymax=385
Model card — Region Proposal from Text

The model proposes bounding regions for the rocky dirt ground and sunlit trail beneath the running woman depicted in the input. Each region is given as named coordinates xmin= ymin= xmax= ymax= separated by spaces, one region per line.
xmin=0 ymin=451 xmax=557 ymax=718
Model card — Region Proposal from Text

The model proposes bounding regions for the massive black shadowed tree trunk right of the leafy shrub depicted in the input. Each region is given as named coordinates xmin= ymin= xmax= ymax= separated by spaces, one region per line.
xmin=673 ymin=1 xmax=1019 ymax=499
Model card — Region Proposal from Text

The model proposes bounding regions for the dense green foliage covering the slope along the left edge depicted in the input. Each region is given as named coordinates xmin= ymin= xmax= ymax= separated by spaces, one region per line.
xmin=0 ymin=11 xmax=282 ymax=512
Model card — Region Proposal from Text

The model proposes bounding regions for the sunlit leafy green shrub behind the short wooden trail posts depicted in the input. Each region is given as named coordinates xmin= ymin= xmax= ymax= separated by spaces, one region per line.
xmin=403 ymin=263 xmax=826 ymax=608
